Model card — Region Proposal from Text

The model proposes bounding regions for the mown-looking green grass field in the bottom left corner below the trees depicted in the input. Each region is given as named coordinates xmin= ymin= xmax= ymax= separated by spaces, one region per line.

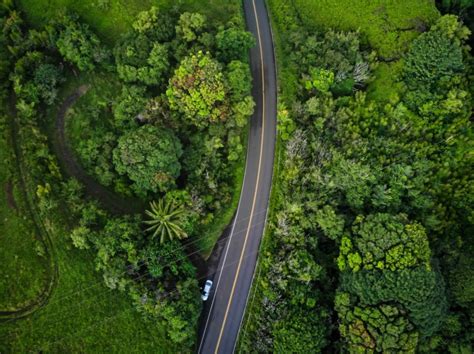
xmin=0 ymin=221 xmax=179 ymax=353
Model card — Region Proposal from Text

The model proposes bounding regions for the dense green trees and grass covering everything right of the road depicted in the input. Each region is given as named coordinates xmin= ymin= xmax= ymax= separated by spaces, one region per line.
xmin=240 ymin=0 xmax=474 ymax=353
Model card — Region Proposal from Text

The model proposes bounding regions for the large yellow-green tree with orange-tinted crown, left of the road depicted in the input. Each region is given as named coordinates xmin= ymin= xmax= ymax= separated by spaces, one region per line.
xmin=166 ymin=51 xmax=228 ymax=128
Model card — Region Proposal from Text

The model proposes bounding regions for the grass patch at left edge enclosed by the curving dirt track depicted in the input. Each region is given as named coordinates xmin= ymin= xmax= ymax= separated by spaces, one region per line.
xmin=0 ymin=124 xmax=49 ymax=311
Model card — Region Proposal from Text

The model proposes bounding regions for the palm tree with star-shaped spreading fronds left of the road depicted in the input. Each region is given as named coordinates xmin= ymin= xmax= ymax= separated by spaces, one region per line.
xmin=144 ymin=199 xmax=188 ymax=243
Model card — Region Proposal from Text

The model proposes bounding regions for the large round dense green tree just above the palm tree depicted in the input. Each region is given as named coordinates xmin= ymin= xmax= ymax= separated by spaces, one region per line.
xmin=113 ymin=125 xmax=183 ymax=196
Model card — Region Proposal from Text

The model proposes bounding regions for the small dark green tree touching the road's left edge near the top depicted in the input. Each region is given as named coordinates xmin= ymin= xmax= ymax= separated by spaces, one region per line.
xmin=216 ymin=27 xmax=255 ymax=63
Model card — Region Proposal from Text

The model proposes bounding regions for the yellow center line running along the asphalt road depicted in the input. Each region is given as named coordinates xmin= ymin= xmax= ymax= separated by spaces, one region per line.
xmin=214 ymin=0 xmax=265 ymax=354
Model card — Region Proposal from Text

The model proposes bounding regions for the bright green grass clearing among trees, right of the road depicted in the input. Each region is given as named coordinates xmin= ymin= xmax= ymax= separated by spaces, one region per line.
xmin=293 ymin=0 xmax=439 ymax=102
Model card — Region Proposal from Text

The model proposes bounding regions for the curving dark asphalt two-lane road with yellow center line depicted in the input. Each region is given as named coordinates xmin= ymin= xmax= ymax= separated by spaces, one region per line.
xmin=198 ymin=0 xmax=276 ymax=353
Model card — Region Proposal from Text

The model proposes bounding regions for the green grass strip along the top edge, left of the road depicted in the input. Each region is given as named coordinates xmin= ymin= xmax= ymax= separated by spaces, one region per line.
xmin=18 ymin=0 xmax=240 ymax=44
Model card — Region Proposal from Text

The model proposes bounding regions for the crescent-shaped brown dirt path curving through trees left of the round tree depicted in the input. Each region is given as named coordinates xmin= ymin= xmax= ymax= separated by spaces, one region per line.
xmin=53 ymin=85 xmax=146 ymax=214
